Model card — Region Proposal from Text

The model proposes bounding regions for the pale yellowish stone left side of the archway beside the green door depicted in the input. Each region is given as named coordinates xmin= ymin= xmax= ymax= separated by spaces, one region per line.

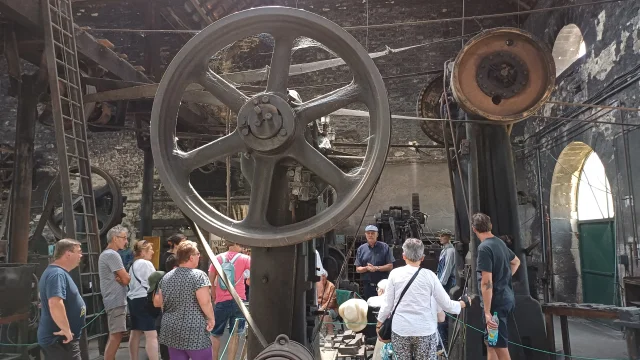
xmin=549 ymin=141 xmax=593 ymax=302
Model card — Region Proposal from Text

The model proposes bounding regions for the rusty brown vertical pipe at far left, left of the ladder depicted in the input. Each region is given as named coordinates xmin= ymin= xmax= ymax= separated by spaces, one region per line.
xmin=9 ymin=75 xmax=38 ymax=264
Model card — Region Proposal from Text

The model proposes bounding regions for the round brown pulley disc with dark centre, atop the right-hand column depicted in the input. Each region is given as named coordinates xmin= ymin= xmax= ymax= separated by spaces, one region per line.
xmin=451 ymin=28 xmax=556 ymax=124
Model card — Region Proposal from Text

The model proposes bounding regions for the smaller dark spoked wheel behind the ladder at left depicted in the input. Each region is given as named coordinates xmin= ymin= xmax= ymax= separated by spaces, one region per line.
xmin=42 ymin=166 xmax=123 ymax=239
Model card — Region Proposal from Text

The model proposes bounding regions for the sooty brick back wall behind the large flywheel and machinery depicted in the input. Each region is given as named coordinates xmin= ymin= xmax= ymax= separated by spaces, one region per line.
xmin=0 ymin=0 xmax=517 ymax=246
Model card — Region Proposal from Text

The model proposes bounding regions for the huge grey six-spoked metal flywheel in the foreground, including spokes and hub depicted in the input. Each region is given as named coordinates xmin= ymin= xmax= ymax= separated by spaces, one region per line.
xmin=151 ymin=7 xmax=391 ymax=247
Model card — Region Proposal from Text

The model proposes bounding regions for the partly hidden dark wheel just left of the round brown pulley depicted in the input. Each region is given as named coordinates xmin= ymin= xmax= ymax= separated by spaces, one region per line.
xmin=416 ymin=75 xmax=452 ymax=145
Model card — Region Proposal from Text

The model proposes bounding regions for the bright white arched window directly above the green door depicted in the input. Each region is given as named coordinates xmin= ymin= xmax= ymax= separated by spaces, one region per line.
xmin=578 ymin=152 xmax=615 ymax=221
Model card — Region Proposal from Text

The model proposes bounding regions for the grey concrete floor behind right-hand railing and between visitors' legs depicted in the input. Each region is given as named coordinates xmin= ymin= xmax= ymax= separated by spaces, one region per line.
xmin=89 ymin=318 xmax=627 ymax=360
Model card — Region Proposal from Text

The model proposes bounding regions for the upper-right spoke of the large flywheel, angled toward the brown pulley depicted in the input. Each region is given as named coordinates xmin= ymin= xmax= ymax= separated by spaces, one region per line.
xmin=296 ymin=83 xmax=362 ymax=124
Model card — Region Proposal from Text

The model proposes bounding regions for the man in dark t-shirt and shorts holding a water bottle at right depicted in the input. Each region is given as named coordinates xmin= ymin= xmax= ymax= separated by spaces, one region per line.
xmin=472 ymin=213 xmax=520 ymax=360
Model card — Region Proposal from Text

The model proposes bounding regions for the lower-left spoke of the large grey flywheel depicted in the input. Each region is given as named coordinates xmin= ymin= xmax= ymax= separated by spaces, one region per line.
xmin=178 ymin=131 xmax=245 ymax=173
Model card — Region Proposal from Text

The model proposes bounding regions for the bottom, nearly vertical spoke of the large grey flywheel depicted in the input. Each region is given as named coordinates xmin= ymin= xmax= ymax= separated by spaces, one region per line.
xmin=242 ymin=156 xmax=277 ymax=227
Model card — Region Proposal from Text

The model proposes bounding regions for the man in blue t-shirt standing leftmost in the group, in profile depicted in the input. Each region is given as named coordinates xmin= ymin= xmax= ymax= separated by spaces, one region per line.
xmin=38 ymin=239 xmax=86 ymax=360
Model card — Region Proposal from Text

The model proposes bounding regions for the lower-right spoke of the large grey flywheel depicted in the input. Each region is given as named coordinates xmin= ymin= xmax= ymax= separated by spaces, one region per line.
xmin=291 ymin=138 xmax=358 ymax=194
